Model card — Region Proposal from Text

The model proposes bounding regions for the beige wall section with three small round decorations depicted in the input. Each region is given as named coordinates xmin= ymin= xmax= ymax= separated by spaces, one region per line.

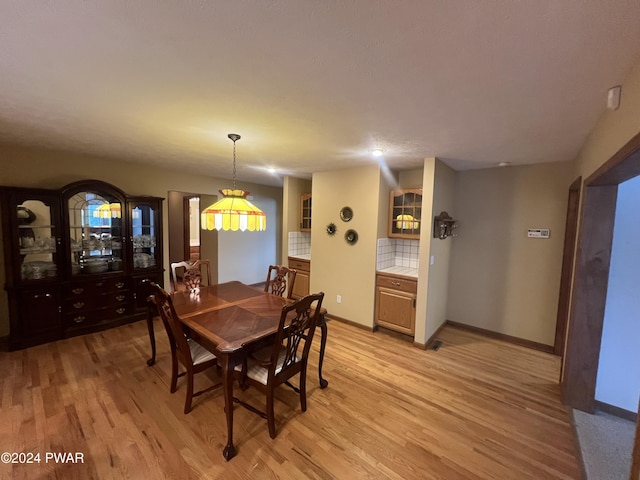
xmin=310 ymin=165 xmax=380 ymax=327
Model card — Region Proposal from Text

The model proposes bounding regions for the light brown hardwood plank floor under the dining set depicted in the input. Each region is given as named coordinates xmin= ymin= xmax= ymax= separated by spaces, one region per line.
xmin=0 ymin=320 xmax=582 ymax=480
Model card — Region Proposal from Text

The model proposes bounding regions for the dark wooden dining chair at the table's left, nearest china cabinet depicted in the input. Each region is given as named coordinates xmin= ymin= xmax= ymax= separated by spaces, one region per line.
xmin=149 ymin=283 xmax=221 ymax=414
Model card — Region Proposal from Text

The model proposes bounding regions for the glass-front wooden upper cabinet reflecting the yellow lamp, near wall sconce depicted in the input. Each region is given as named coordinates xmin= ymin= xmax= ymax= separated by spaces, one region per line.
xmin=388 ymin=188 xmax=422 ymax=239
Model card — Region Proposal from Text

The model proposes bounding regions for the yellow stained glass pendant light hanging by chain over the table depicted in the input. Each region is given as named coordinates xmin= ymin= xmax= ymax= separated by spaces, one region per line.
xmin=200 ymin=133 xmax=267 ymax=232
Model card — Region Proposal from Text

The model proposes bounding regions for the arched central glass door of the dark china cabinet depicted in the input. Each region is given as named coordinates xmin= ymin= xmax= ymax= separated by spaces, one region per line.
xmin=67 ymin=191 xmax=124 ymax=277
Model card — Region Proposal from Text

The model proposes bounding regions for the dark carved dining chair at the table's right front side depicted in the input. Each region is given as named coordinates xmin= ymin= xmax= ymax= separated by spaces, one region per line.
xmin=234 ymin=292 xmax=324 ymax=438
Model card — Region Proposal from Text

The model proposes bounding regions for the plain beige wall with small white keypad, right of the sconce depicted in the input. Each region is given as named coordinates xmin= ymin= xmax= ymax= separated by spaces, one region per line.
xmin=447 ymin=162 xmax=574 ymax=345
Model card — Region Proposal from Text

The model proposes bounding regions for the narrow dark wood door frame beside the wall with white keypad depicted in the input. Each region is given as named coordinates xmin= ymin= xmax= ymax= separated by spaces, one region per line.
xmin=553 ymin=177 xmax=582 ymax=356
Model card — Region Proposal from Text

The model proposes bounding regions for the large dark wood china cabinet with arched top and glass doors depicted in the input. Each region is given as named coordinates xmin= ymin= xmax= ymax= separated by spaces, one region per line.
xmin=0 ymin=180 xmax=163 ymax=349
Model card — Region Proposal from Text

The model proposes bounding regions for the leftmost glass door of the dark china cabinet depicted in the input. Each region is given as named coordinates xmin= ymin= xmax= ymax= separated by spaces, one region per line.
xmin=14 ymin=196 xmax=61 ymax=283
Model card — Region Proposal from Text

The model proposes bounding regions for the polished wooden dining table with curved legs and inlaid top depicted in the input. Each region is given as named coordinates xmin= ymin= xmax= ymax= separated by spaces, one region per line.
xmin=147 ymin=281 xmax=328 ymax=460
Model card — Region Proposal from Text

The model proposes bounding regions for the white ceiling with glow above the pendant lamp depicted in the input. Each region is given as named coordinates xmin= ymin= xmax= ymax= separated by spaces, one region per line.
xmin=0 ymin=0 xmax=640 ymax=185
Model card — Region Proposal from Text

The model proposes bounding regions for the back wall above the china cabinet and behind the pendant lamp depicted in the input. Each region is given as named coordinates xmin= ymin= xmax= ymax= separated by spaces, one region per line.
xmin=0 ymin=144 xmax=282 ymax=336
